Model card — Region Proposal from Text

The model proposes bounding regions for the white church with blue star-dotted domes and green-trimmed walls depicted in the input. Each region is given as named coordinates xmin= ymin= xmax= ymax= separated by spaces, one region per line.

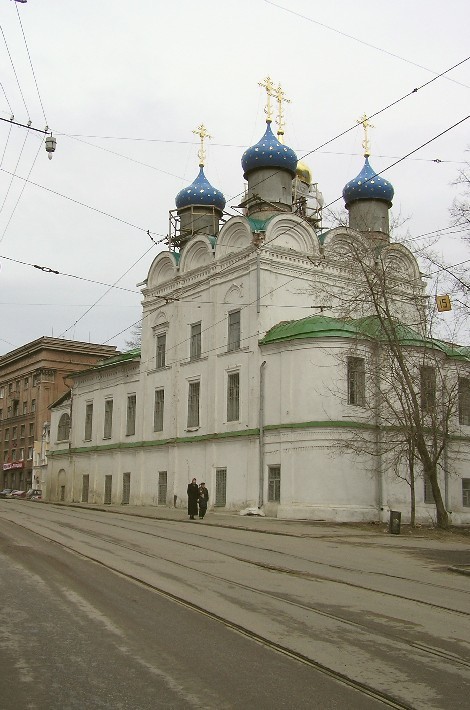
xmin=45 ymin=87 xmax=470 ymax=524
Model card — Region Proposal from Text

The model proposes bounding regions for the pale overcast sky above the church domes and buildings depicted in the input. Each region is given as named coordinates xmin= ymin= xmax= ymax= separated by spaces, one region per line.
xmin=0 ymin=0 xmax=470 ymax=354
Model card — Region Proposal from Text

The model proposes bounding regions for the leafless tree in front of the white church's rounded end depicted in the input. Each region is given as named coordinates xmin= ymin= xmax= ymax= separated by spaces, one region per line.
xmin=324 ymin=230 xmax=468 ymax=528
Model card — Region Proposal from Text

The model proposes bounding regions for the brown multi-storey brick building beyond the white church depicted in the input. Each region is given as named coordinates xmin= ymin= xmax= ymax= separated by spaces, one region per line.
xmin=0 ymin=337 xmax=116 ymax=490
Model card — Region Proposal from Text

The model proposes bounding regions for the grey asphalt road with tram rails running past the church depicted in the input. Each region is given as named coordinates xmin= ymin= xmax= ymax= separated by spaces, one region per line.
xmin=0 ymin=501 xmax=470 ymax=710
